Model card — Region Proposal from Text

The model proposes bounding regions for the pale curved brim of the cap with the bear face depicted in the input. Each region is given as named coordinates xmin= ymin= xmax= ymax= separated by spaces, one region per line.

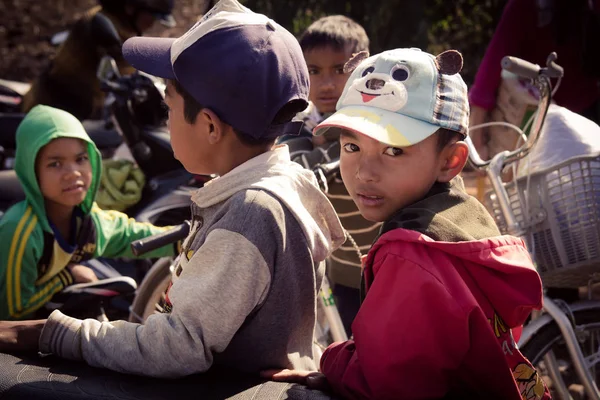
xmin=313 ymin=106 xmax=440 ymax=147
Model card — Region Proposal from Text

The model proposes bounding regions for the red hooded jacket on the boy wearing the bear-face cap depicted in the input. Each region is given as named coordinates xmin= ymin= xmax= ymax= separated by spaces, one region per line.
xmin=321 ymin=228 xmax=550 ymax=400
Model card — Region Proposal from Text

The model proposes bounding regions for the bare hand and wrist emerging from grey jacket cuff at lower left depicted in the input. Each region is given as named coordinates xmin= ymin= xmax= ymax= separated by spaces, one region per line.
xmin=0 ymin=319 xmax=46 ymax=353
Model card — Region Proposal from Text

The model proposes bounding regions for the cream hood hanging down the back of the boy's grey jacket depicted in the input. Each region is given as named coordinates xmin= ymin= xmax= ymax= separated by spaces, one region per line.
xmin=192 ymin=146 xmax=346 ymax=262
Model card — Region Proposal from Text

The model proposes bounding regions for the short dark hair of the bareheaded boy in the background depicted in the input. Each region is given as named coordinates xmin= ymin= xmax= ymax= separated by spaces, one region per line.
xmin=299 ymin=15 xmax=369 ymax=54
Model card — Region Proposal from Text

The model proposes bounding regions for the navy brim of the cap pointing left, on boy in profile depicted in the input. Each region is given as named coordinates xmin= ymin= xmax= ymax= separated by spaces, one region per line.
xmin=123 ymin=37 xmax=175 ymax=79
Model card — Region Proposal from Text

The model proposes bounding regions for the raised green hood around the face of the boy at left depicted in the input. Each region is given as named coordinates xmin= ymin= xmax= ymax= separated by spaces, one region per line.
xmin=15 ymin=105 xmax=102 ymax=232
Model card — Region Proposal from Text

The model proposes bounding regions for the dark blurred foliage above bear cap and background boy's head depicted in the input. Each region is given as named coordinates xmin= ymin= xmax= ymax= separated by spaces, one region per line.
xmin=243 ymin=0 xmax=506 ymax=83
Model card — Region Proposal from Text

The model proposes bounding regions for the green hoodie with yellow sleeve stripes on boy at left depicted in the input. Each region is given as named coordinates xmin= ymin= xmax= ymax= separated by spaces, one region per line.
xmin=0 ymin=105 xmax=175 ymax=320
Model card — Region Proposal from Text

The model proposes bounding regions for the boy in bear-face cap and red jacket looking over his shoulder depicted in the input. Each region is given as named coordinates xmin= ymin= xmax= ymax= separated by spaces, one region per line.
xmin=265 ymin=49 xmax=550 ymax=400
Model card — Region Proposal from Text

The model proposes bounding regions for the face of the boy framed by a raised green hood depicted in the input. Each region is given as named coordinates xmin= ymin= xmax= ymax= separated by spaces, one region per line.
xmin=36 ymin=138 xmax=92 ymax=207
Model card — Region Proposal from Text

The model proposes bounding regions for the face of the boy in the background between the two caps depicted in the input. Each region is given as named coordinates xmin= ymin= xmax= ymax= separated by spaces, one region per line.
xmin=304 ymin=46 xmax=352 ymax=113
